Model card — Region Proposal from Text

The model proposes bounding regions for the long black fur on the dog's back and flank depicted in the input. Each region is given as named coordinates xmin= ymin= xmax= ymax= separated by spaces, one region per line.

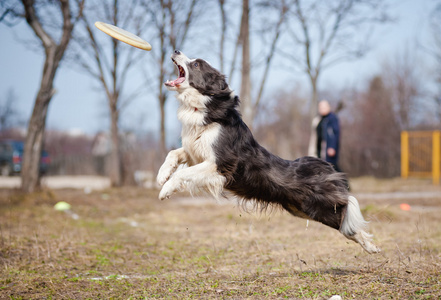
xmin=215 ymin=106 xmax=348 ymax=229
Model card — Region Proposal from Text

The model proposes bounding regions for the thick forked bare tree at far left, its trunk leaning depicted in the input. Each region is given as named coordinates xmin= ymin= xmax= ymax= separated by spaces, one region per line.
xmin=2 ymin=0 xmax=84 ymax=192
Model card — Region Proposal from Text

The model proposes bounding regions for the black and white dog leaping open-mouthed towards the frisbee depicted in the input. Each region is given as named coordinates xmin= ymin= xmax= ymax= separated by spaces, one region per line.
xmin=157 ymin=50 xmax=380 ymax=253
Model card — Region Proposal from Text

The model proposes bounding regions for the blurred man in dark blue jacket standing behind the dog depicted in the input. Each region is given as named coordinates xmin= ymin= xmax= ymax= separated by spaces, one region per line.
xmin=316 ymin=100 xmax=341 ymax=172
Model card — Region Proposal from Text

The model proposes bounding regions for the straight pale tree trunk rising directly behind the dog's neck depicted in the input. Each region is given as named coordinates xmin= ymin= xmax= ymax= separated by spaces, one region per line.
xmin=240 ymin=0 xmax=253 ymax=128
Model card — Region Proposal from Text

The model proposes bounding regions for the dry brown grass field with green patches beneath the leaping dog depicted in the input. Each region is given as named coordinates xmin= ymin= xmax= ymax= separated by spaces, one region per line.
xmin=0 ymin=178 xmax=441 ymax=299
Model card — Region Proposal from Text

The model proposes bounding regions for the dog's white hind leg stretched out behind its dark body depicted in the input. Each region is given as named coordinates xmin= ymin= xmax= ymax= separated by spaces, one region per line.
xmin=340 ymin=196 xmax=381 ymax=254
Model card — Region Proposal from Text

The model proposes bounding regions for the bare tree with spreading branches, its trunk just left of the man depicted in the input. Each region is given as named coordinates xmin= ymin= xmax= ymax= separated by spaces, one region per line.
xmin=281 ymin=0 xmax=388 ymax=154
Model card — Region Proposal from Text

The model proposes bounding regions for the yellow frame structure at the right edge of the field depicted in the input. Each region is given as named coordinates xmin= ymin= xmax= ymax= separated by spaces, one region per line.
xmin=401 ymin=130 xmax=441 ymax=184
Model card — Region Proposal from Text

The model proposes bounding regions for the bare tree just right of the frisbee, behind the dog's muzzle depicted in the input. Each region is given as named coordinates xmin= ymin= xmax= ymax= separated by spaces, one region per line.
xmin=143 ymin=0 xmax=203 ymax=156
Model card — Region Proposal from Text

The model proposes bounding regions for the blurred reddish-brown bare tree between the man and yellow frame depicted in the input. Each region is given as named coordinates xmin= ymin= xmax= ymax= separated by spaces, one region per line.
xmin=341 ymin=76 xmax=401 ymax=177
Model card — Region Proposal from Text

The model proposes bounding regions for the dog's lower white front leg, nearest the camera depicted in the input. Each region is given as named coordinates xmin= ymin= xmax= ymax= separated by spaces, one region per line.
xmin=159 ymin=161 xmax=226 ymax=200
